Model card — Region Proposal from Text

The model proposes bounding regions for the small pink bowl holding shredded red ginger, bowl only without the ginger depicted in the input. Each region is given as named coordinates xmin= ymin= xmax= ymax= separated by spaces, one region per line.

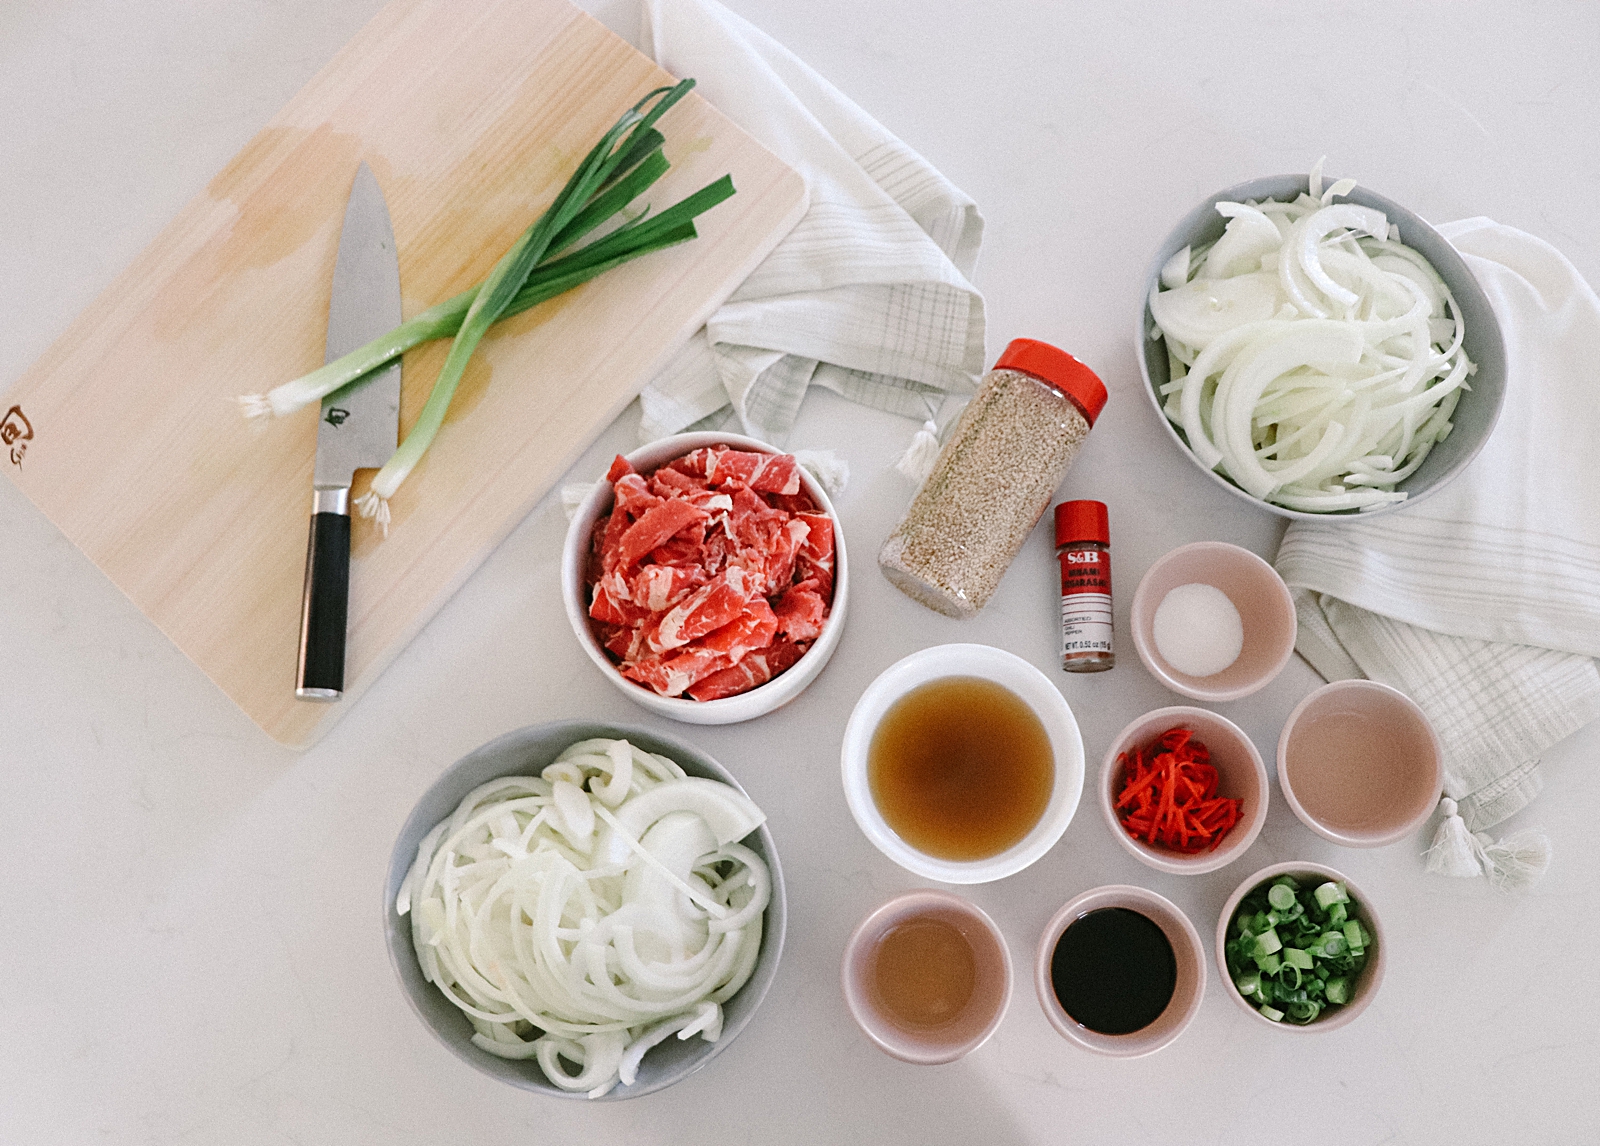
xmin=1099 ymin=704 xmax=1270 ymax=876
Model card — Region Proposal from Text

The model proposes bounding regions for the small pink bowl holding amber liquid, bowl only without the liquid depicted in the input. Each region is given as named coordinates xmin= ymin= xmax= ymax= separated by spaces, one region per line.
xmin=840 ymin=888 xmax=1011 ymax=1066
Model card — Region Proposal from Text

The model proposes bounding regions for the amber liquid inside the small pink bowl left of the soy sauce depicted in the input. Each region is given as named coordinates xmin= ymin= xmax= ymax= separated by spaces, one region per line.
xmin=872 ymin=916 xmax=978 ymax=1032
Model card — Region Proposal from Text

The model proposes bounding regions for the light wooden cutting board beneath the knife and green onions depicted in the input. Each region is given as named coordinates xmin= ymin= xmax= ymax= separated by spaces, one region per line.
xmin=0 ymin=0 xmax=805 ymax=746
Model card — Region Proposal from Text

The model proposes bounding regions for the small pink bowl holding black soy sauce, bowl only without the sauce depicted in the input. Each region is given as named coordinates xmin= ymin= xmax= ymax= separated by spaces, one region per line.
xmin=1034 ymin=884 xmax=1205 ymax=1058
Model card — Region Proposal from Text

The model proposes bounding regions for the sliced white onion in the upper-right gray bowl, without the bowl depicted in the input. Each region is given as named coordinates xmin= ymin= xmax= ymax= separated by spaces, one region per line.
xmin=1150 ymin=178 xmax=1475 ymax=512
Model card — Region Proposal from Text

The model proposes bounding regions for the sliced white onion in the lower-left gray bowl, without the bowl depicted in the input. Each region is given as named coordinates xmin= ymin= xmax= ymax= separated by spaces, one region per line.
xmin=406 ymin=741 xmax=771 ymax=1098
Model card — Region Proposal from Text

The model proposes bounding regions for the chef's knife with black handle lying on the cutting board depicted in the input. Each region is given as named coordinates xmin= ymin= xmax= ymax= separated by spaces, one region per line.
xmin=294 ymin=163 xmax=400 ymax=701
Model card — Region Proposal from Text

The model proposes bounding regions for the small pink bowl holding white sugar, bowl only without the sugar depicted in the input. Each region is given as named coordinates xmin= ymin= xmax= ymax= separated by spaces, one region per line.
xmin=1133 ymin=541 xmax=1294 ymax=703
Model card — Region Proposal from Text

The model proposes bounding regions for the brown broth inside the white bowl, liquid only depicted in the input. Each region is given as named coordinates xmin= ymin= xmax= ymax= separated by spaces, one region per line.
xmin=867 ymin=677 xmax=1056 ymax=860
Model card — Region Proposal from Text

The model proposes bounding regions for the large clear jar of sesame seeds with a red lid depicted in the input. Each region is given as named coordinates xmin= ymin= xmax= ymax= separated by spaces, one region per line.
xmin=878 ymin=338 xmax=1106 ymax=616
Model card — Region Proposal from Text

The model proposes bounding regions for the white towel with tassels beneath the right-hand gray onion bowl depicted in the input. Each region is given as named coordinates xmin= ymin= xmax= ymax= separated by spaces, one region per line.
xmin=1277 ymin=218 xmax=1600 ymax=831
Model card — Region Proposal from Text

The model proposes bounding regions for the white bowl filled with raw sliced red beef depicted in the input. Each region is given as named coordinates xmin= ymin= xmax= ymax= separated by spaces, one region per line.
xmin=562 ymin=432 xmax=846 ymax=723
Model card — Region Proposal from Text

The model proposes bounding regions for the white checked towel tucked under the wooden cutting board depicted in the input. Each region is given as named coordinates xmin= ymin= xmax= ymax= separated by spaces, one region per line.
xmin=640 ymin=0 xmax=984 ymax=442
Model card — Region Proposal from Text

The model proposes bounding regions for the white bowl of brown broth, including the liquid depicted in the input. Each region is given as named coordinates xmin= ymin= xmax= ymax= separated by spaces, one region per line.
xmin=840 ymin=645 xmax=1083 ymax=884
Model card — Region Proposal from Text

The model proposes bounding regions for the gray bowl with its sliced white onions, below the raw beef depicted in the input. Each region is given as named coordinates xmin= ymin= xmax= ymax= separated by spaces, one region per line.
xmin=384 ymin=720 xmax=787 ymax=1101
